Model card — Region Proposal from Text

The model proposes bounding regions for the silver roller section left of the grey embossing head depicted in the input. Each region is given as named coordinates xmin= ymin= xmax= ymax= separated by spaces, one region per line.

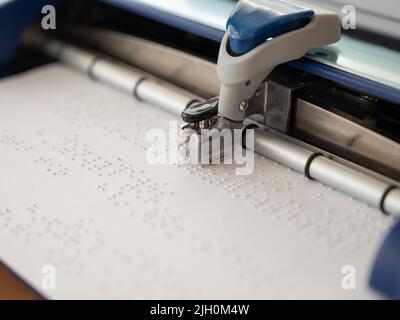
xmin=24 ymin=33 xmax=202 ymax=116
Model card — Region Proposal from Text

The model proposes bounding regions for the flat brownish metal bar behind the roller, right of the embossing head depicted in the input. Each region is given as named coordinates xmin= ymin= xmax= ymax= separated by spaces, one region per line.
xmin=291 ymin=98 xmax=400 ymax=179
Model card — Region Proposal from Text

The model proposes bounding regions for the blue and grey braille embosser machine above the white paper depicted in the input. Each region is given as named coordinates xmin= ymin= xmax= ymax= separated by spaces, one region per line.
xmin=0 ymin=0 xmax=400 ymax=297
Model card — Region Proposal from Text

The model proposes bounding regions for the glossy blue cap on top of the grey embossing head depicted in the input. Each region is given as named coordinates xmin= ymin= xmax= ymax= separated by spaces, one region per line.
xmin=226 ymin=0 xmax=314 ymax=55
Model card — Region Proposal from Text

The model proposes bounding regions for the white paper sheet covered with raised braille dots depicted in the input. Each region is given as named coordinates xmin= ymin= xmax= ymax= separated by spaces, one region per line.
xmin=0 ymin=64 xmax=392 ymax=299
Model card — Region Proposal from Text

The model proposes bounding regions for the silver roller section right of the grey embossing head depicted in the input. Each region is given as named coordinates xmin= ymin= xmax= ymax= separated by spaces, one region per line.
xmin=254 ymin=129 xmax=400 ymax=217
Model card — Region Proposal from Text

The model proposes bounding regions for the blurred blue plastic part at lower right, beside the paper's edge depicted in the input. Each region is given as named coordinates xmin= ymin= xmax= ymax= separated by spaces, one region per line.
xmin=370 ymin=222 xmax=400 ymax=299
